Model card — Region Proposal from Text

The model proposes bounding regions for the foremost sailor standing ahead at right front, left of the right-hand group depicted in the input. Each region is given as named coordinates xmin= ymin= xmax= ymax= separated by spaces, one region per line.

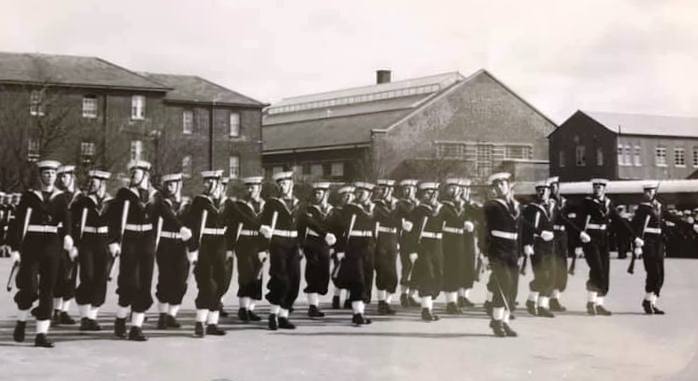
xmin=484 ymin=172 xmax=521 ymax=337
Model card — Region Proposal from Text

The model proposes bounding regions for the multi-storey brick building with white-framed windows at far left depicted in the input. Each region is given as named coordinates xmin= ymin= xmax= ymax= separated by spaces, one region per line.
xmin=0 ymin=53 xmax=264 ymax=190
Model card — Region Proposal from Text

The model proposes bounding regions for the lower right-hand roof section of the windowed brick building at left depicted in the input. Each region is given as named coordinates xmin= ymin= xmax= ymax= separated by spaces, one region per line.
xmin=141 ymin=73 xmax=265 ymax=107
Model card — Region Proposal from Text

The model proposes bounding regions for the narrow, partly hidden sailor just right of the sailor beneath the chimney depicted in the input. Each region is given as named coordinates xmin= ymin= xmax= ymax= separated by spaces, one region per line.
xmin=397 ymin=179 xmax=420 ymax=308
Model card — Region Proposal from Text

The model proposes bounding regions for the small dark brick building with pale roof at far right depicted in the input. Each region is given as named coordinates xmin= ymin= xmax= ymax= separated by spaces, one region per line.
xmin=549 ymin=111 xmax=698 ymax=181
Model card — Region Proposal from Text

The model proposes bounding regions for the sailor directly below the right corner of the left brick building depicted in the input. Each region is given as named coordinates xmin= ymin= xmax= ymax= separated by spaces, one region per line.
xmin=224 ymin=176 xmax=268 ymax=322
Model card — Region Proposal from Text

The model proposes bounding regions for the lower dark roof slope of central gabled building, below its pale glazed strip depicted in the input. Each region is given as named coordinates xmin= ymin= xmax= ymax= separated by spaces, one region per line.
xmin=262 ymin=109 xmax=410 ymax=152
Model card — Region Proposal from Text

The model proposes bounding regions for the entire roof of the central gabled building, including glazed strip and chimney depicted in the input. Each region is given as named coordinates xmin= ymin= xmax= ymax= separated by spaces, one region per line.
xmin=262 ymin=70 xmax=555 ymax=154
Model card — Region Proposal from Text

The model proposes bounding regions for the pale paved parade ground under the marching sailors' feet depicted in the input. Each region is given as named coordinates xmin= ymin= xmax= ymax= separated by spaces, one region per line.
xmin=0 ymin=255 xmax=698 ymax=381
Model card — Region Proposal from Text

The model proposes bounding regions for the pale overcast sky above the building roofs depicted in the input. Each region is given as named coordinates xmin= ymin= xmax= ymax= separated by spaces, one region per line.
xmin=0 ymin=0 xmax=698 ymax=123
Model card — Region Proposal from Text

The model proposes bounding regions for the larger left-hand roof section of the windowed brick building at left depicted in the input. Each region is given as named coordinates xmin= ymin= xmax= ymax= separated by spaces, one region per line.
xmin=0 ymin=52 xmax=169 ymax=92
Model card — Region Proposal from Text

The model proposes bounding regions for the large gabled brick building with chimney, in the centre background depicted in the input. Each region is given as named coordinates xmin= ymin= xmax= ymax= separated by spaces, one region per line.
xmin=262 ymin=70 xmax=556 ymax=181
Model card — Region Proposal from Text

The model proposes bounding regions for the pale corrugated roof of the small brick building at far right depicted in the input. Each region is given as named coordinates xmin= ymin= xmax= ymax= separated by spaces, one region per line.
xmin=581 ymin=111 xmax=698 ymax=138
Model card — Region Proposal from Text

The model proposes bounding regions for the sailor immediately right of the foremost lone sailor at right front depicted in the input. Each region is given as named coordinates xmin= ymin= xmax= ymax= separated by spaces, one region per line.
xmin=521 ymin=181 xmax=557 ymax=317
